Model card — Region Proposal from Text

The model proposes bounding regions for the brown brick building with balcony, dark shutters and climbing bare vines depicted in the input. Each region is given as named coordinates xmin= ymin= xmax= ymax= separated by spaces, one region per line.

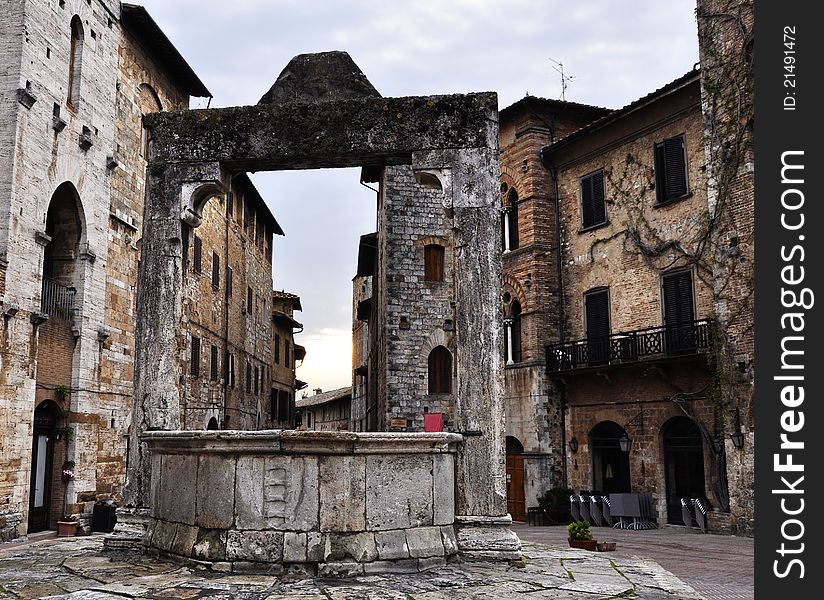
xmin=501 ymin=2 xmax=754 ymax=534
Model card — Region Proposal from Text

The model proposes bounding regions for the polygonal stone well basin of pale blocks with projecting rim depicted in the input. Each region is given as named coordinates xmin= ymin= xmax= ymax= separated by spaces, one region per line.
xmin=142 ymin=430 xmax=463 ymax=576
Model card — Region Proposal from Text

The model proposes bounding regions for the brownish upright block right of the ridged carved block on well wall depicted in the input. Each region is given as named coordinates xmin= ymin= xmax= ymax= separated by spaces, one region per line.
xmin=318 ymin=456 xmax=366 ymax=531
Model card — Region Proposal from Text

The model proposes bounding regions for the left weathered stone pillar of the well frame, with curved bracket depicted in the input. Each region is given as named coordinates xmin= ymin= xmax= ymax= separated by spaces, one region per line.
xmin=124 ymin=162 xmax=224 ymax=508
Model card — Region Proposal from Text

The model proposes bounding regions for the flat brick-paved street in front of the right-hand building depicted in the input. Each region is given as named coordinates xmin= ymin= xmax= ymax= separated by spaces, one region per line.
xmin=512 ymin=524 xmax=755 ymax=600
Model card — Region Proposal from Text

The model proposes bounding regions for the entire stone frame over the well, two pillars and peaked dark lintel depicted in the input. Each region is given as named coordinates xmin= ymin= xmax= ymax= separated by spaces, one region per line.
xmin=126 ymin=52 xmax=520 ymax=558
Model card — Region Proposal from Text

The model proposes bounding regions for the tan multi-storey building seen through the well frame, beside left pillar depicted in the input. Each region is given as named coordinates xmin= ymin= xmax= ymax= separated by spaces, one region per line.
xmin=180 ymin=173 xmax=284 ymax=429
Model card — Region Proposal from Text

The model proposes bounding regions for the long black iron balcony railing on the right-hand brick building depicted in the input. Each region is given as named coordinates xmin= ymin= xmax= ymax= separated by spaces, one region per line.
xmin=546 ymin=319 xmax=713 ymax=372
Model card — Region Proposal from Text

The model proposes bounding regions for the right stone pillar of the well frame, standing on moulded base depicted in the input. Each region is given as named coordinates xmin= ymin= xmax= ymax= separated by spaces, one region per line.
xmin=412 ymin=148 xmax=521 ymax=559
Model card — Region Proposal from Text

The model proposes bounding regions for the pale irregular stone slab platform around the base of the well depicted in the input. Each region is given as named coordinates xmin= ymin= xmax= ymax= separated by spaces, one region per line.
xmin=0 ymin=535 xmax=702 ymax=600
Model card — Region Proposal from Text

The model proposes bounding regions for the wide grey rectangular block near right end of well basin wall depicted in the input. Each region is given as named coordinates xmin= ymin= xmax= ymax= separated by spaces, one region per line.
xmin=366 ymin=454 xmax=432 ymax=530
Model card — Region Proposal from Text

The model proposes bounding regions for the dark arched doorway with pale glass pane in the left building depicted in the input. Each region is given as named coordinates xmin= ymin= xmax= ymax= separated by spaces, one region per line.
xmin=29 ymin=400 xmax=59 ymax=533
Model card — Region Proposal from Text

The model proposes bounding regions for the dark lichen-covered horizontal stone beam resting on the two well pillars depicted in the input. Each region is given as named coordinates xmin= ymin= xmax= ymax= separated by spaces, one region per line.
xmin=146 ymin=92 xmax=498 ymax=172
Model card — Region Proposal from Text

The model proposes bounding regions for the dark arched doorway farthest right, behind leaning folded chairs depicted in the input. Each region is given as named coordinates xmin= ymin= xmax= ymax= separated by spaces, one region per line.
xmin=662 ymin=417 xmax=706 ymax=525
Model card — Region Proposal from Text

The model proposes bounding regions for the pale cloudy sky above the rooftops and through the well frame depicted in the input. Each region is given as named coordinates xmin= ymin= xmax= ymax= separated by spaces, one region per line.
xmin=136 ymin=0 xmax=698 ymax=393
